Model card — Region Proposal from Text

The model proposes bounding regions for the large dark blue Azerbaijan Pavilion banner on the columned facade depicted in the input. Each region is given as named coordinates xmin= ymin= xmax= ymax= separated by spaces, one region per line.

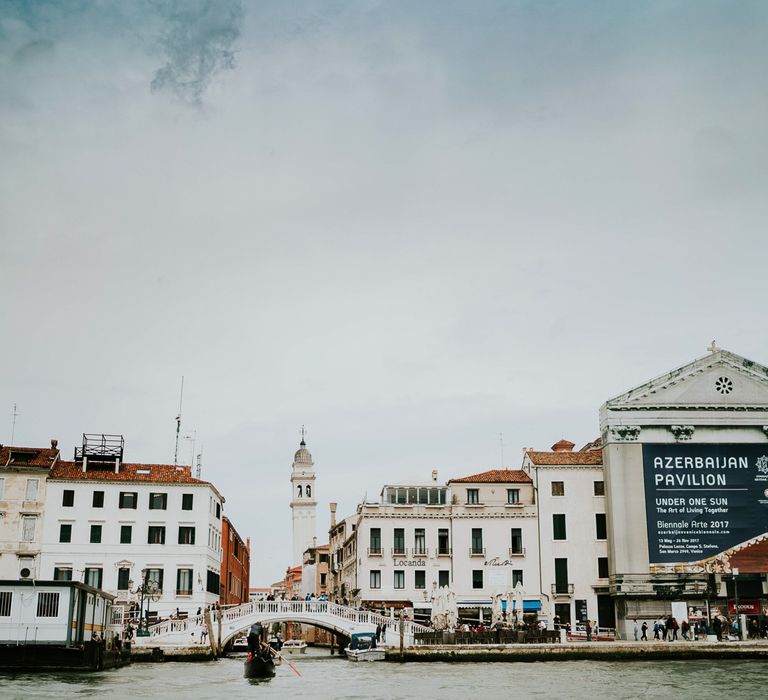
xmin=643 ymin=444 xmax=768 ymax=572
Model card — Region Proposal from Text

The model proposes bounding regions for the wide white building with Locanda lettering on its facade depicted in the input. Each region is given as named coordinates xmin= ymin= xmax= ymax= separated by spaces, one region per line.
xmin=331 ymin=469 xmax=540 ymax=620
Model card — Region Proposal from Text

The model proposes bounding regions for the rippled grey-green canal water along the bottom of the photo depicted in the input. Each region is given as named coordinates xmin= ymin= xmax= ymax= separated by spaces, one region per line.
xmin=0 ymin=656 xmax=768 ymax=700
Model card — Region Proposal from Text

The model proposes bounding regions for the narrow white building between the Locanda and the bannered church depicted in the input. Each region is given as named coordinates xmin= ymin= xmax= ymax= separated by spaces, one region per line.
xmin=523 ymin=440 xmax=616 ymax=628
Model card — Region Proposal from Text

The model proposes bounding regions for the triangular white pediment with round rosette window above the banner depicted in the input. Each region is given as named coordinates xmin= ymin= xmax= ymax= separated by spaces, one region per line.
xmin=604 ymin=350 xmax=768 ymax=411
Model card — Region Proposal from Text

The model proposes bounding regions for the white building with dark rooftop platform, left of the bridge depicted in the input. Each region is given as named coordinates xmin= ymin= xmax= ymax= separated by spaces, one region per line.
xmin=39 ymin=436 xmax=224 ymax=616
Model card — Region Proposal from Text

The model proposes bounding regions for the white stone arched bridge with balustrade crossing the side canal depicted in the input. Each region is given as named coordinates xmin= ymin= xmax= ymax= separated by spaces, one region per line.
xmin=135 ymin=600 xmax=429 ymax=648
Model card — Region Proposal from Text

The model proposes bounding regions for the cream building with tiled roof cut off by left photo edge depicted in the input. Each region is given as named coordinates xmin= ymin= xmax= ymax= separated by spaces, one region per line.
xmin=0 ymin=440 xmax=59 ymax=580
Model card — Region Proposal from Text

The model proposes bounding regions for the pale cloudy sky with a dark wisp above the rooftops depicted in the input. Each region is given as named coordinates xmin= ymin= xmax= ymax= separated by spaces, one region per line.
xmin=0 ymin=0 xmax=768 ymax=585
